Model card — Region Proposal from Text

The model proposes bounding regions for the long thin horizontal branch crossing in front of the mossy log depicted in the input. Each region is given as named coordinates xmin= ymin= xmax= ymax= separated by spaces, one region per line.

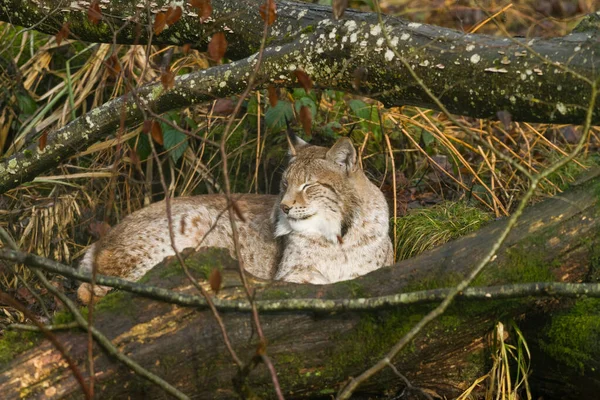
xmin=0 ymin=249 xmax=600 ymax=313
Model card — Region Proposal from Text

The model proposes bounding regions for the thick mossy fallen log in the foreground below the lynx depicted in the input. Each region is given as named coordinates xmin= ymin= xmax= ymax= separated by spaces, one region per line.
xmin=0 ymin=172 xmax=600 ymax=399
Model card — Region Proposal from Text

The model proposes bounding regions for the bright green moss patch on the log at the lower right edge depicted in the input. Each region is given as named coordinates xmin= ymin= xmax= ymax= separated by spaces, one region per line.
xmin=540 ymin=299 xmax=600 ymax=374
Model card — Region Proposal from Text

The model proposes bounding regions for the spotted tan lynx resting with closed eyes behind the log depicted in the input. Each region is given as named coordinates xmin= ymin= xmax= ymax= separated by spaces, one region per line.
xmin=78 ymin=138 xmax=393 ymax=303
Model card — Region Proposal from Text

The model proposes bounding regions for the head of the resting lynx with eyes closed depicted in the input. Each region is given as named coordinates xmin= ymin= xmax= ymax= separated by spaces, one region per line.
xmin=274 ymin=137 xmax=366 ymax=243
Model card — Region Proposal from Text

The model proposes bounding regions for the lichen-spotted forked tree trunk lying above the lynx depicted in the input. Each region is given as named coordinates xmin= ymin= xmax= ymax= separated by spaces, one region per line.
xmin=0 ymin=0 xmax=600 ymax=193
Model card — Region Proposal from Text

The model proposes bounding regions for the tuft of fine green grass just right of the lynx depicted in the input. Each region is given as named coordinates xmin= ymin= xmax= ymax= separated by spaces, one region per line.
xmin=396 ymin=202 xmax=492 ymax=260
